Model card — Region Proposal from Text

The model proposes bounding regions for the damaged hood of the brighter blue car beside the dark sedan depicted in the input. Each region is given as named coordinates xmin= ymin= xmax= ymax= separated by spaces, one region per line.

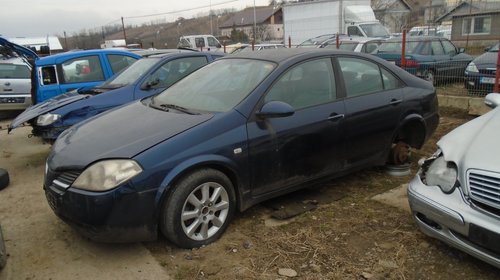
xmin=9 ymin=91 xmax=89 ymax=132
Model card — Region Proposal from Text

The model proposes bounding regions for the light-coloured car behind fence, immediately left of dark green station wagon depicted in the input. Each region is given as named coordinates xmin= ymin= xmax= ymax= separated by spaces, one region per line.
xmin=322 ymin=37 xmax=385 ymax=53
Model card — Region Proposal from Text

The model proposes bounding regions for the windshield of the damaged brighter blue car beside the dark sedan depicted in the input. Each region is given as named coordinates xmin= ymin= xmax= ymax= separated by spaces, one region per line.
xmin=99 ymin=57 xmax=159 ymax=88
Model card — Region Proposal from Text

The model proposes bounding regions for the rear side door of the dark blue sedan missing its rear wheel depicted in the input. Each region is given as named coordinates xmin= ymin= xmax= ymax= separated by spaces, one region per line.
xmin=337 ymin=57 xmax=403 ymax=168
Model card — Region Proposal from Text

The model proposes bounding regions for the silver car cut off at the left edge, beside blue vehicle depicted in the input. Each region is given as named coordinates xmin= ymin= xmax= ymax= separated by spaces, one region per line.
xmin=0 ymin=55 xmax=31 ymax=111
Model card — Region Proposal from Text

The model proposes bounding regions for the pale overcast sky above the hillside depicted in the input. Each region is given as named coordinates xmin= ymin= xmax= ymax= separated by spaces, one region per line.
xmin=0 ymin=0 xmax=269 ymax=38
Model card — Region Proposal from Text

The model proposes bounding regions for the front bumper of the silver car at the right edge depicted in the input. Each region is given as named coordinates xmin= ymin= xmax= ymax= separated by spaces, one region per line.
xmin=408 ymin=174 xmax=500 ymax=268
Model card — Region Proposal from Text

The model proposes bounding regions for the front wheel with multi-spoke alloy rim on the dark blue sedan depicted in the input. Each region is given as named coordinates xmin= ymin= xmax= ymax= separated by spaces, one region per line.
xmin=160 ymin=169 xmax=236 ymax=248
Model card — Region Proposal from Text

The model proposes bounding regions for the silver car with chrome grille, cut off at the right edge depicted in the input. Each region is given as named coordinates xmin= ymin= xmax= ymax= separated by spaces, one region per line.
xmin=408 ymin=93 xmax=500 ymax=268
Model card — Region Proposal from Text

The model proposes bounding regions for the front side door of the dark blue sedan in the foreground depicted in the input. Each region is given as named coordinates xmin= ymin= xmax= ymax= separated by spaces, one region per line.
xmin=247 ymin=58 xmax=344 ymax=196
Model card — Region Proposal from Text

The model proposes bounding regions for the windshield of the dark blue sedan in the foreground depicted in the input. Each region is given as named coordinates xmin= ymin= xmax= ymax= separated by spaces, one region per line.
xmin=152 ymin=59 xmax=276 ymax=112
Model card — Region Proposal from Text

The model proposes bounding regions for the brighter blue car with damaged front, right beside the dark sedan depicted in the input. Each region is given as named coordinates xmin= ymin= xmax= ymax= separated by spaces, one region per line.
xmin=9 ymin=49 xmax=224 ymax=141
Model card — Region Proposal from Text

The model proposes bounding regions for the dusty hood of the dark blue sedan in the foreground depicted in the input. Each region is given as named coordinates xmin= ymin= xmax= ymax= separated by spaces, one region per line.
xmin=48 ymin=101 xmax=213 ymax=170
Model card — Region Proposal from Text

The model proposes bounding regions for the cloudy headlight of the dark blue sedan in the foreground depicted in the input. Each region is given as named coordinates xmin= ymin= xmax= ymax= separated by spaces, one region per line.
xmin=72 ymin=159 xmax=142 ymax=192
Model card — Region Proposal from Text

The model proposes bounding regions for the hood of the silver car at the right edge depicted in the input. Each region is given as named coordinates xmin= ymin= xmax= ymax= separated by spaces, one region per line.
xmin=437 ymin=107 xmax=500 ymax=173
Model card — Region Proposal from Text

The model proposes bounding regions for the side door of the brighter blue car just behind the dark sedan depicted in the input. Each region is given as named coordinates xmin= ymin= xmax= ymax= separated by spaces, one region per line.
xmin=134 ymin=55 xmax=208 ymax=99
